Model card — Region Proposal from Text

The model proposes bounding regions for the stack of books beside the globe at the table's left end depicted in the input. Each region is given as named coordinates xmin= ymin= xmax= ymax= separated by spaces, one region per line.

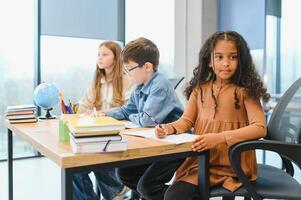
xmin=5 ymin=104 xmax=37 ymax=124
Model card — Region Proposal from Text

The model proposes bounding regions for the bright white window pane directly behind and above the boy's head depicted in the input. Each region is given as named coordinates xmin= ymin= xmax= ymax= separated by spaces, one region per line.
xmin=125 ymin=0 xmax=175 ymax=78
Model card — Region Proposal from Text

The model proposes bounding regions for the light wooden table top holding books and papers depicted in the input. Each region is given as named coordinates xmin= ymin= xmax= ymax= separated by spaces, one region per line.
xmin=5 ymin=120 xmax=191 ymax=168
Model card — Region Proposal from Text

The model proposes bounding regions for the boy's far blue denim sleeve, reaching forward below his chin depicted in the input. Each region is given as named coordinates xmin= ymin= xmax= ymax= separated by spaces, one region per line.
xmin=105 ymin=92 xmax=138 ymax=120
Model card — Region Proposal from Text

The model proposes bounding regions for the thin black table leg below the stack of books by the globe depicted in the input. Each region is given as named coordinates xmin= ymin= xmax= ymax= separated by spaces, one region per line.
xmin=7 ymin=129 xmax=14 ymax=200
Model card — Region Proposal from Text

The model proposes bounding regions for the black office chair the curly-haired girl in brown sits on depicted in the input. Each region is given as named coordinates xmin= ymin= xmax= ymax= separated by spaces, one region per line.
xmin=200 ymin=78 xmax=301 ymax=200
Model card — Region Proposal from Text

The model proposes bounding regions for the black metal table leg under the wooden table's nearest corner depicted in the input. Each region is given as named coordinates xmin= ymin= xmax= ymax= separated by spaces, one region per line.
xmin=61 ymin=168 xmax=73 ymax=200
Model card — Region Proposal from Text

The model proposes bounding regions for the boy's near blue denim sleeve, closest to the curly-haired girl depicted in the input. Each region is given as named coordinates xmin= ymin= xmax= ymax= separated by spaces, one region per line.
xmin=129 ymin=88 xmax=175 ymax=127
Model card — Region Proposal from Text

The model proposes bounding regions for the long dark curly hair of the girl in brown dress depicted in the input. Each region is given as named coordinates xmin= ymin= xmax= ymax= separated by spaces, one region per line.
xmin=184 ymin=31 xmax=269 ymax=101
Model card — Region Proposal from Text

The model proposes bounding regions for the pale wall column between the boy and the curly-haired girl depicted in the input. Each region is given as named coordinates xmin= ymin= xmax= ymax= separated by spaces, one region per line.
xmin=174 ymin=0 xmax=217 ymax=82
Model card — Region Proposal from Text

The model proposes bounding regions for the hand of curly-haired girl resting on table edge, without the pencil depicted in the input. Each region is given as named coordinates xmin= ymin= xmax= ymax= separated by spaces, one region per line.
xmin=191 ymin=133 xmax=225 ymax=152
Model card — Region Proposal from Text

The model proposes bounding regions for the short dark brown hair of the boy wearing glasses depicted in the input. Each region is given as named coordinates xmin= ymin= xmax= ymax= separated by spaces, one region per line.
xmin=121 ymin=37 xmax=160 ymax=71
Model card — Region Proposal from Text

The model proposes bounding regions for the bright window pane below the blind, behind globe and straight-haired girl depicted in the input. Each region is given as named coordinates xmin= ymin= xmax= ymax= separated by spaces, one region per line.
xmin=41 ymin=35 xmax=123 ymax=115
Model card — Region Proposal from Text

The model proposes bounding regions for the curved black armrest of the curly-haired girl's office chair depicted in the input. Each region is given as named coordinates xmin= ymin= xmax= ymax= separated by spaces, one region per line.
xmin=229 ymin=140 xmax=301 ymax=200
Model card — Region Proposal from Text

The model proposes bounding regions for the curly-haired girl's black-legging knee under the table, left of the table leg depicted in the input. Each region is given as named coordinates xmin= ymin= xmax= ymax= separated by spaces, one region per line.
xmin=164 ymin=181 xmax=199 ymax=200
